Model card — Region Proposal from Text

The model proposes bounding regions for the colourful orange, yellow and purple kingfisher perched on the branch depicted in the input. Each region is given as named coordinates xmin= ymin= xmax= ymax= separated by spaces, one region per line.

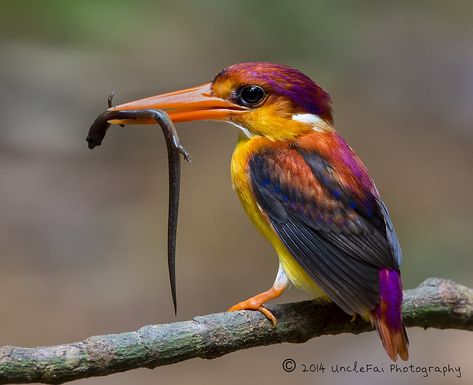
xmin=108 ymin=62 xmax=409 ymax=361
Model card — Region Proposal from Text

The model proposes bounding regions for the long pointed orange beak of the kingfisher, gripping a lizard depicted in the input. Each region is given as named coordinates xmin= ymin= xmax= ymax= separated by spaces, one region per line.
xmin=107 ymin=83 xmax=248 ymax=124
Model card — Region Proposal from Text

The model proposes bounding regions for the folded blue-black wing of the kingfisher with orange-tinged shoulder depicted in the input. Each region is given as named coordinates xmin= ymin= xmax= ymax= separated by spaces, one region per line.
xmin=249 ymin=150 xmax=399 ymax=314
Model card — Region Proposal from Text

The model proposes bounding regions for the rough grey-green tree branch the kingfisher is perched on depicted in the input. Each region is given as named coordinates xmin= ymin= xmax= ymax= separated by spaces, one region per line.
xmin=0 ymin=278 xmax=473 ymax=384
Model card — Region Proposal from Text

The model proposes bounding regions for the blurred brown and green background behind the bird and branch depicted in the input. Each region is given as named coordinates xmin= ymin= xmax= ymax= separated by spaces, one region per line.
xmin=0 ymin=0 xmax=473 ymax=385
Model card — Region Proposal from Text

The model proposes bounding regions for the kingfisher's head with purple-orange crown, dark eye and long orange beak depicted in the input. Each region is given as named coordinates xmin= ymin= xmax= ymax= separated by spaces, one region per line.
xmin=109 ymin=62 xmax=333 ymax=140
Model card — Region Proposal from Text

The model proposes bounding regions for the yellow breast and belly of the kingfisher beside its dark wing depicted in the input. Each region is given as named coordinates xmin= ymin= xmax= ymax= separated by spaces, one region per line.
xmin=231 ymin=136 xmax=326 ymax=297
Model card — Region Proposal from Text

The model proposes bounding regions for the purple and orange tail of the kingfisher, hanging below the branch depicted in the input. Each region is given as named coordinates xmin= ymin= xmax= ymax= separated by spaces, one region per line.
xmin=370 ymin=269 xmax=409 ymax=361
